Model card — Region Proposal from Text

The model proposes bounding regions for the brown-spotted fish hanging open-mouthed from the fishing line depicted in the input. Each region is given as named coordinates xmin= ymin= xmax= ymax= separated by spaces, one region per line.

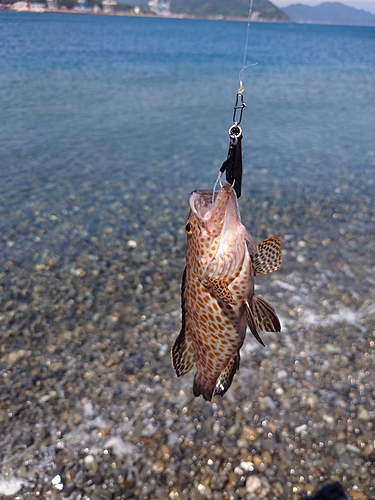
xmin=171 ymin=184 xmax=282 ymax=401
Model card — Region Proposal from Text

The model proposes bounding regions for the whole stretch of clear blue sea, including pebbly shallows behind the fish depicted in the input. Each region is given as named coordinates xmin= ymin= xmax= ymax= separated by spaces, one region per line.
xmin=0 ymin=12 xmax=375 ymax=499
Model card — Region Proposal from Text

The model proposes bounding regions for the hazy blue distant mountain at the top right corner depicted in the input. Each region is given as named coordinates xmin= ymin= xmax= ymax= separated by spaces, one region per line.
xmin=282 ymin=2 xmax=375 ymax=26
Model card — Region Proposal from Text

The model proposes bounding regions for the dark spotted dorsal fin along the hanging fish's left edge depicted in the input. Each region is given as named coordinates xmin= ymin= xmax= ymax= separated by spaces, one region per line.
xmin=172 ymin=267 xmax=195 ymax=377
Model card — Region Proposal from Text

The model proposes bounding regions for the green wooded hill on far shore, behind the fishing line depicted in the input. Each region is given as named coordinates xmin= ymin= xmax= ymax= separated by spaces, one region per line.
xmin=170 ymin=0 xmax=288 ymax=21
